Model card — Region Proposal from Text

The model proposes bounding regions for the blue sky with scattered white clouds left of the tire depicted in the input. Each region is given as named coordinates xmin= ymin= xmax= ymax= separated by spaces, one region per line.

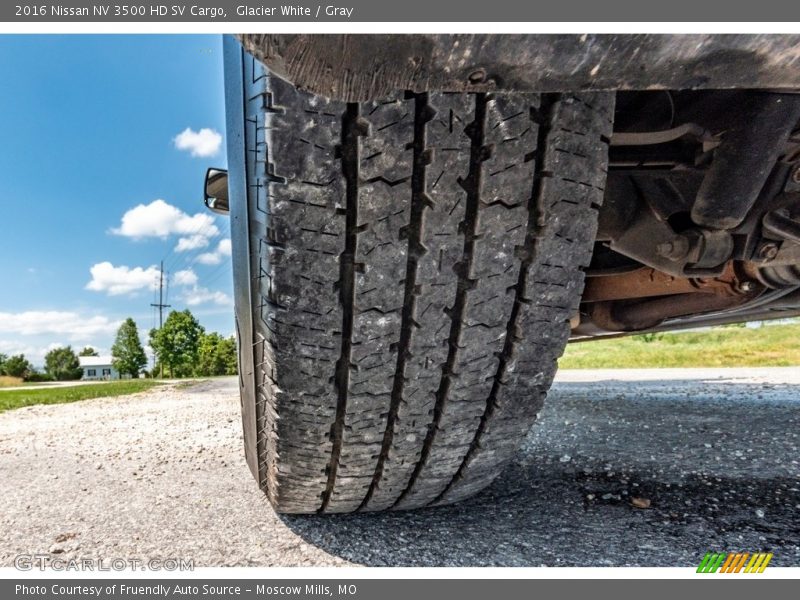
xmin=0 ymin=35 xmax=234 ymax=365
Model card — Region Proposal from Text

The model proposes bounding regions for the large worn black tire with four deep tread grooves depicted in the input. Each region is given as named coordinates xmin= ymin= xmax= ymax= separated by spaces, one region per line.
xmin=234 ymin=49 xmax=614 ymax=513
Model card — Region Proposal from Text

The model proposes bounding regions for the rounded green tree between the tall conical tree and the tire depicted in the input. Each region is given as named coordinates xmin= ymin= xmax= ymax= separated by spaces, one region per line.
xmin=150 ymin=309 xmax=205 ymax=377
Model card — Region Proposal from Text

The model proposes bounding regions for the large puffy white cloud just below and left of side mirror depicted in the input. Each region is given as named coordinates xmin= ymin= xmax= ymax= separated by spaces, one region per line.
xmin=111 ymin=199 xmax=219 ymax=243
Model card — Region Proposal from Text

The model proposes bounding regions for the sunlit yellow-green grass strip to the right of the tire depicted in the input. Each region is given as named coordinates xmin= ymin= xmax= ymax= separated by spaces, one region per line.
xmin=559 ymin=322 xmax=800 ymax=369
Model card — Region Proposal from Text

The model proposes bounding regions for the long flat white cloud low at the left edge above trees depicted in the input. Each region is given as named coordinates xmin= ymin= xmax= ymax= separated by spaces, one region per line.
xmin=0 ymin=310 xmax=120 ymax=342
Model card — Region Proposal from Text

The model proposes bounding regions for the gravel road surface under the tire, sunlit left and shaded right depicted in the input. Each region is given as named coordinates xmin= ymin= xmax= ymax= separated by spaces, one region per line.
xmin=0 ymin=369 xmax=800 ymax=566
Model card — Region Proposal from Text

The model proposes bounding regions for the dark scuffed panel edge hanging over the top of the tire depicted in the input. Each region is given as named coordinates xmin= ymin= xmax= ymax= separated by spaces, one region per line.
xmin=238 ymin=34 xmax=800 ymax=102
